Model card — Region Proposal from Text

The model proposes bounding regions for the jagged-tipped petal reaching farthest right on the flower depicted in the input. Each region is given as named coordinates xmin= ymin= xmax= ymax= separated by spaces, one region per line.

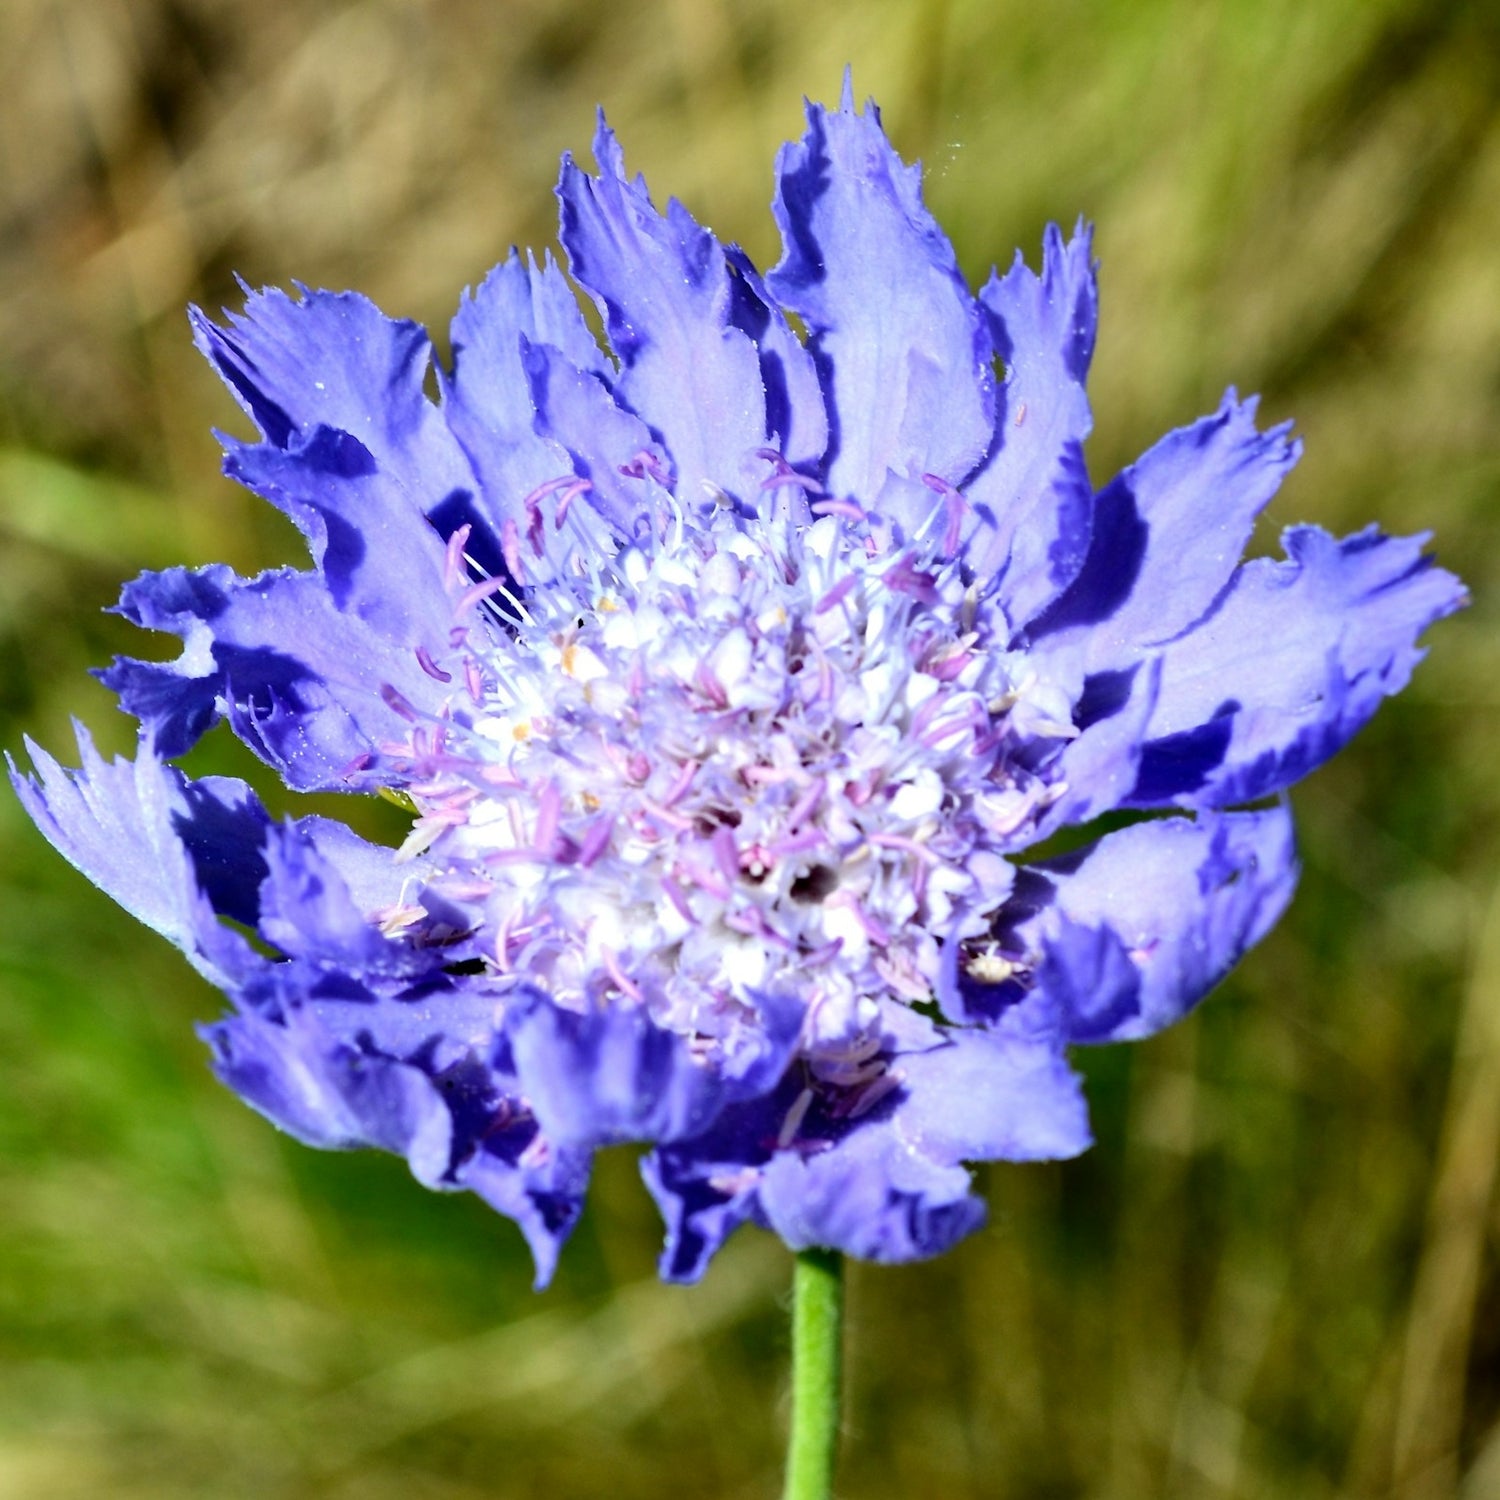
xmin=1131 ymin=527 xmax=1467 ymax=807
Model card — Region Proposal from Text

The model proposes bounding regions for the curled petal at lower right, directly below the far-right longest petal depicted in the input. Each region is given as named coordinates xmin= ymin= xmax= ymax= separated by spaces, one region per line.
xmin=1017 ymin=807 xmax=1298 ymax=1043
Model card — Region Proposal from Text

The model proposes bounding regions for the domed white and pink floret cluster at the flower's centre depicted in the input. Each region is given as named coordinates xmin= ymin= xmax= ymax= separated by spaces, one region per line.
xmin=375 ymin=474 xmax=1074 ymax=1085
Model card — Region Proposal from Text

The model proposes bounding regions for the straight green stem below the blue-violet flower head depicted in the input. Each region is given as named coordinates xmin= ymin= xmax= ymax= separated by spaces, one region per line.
xmin=785 ymin=1250 xmax=843 ymax=1500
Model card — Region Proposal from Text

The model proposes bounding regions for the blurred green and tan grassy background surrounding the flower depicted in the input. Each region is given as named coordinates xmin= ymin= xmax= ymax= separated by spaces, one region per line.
xmin=0 ymin=0 xmax=1500 ymax=1500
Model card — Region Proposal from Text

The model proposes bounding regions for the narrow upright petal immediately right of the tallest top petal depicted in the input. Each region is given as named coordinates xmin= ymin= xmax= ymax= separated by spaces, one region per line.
xmin=963 ymin=222 xmax=1100 ymax=630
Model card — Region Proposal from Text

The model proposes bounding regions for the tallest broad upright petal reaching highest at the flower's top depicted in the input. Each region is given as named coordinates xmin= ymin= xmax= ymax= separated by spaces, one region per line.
xmin=767 ymin=83 xmax=995 ymax=534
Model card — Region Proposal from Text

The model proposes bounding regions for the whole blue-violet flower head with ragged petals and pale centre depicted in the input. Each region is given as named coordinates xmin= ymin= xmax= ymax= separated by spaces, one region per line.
xmin=12 ymin=90 xmax=1463 ymax=1281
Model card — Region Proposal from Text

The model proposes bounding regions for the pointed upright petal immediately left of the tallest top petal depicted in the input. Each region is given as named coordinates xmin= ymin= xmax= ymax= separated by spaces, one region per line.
xmin=558 ymin=114 xmax=767 ymax=506
